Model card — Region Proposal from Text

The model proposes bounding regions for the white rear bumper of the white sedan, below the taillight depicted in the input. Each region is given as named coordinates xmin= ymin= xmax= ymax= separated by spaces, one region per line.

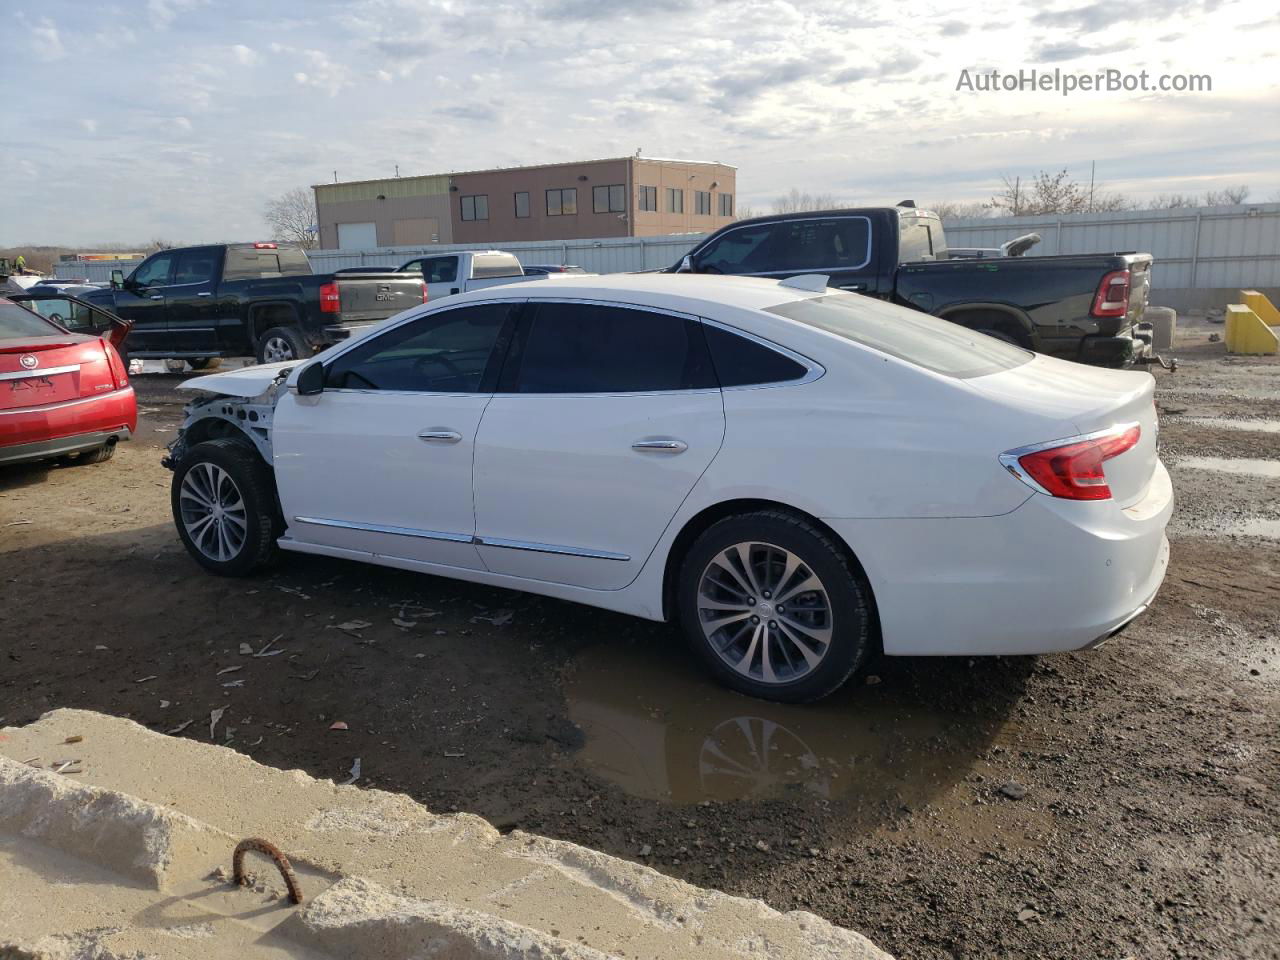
xmin=826 ymin=463 xmax=1174 ymax=655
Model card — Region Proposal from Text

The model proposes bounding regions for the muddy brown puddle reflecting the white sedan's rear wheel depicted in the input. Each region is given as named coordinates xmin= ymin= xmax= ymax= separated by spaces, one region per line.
xmin=566 ymin=644 xmax=975 ymax=805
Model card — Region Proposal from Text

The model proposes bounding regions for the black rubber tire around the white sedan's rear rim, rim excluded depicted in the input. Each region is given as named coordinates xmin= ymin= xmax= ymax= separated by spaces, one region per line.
xmin=676 ymin=512 xmax=874 ymax=703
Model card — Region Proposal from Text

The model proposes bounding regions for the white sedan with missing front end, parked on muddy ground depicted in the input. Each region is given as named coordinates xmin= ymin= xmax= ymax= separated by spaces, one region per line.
xmin=166 ymin=274 xmax=1172 ymax=701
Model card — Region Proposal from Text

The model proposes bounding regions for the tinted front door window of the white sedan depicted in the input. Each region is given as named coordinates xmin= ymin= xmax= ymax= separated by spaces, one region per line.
xmin=325 ymin=303 xmax=512 ymax=393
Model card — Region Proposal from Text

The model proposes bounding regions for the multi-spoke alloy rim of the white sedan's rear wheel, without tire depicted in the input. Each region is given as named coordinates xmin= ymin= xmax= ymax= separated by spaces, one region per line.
xmin=698 ymin=541 xmax=833 ymax=684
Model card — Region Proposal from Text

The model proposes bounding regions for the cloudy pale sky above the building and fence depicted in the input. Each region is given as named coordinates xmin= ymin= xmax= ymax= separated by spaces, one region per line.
xmin=0 ymin=0 xmax=1280 ymax=244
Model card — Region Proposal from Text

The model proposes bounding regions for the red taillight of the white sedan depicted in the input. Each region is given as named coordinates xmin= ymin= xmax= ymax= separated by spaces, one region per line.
xmin=1000 ymin=424 xmax=1142 ymax=500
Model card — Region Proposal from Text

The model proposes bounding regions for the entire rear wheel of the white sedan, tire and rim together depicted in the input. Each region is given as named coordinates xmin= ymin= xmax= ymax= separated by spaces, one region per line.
xmin=676 ymin=511 xmax=876 ymax=703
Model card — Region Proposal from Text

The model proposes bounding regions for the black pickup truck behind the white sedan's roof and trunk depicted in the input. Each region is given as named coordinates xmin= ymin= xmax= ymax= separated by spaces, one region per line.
xmin=667 ymin=206 xmax=1152 ymax=366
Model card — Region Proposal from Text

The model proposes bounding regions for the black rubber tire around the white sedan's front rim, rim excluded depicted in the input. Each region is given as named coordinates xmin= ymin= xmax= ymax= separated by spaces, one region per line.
xmin=170 ymin=439 xmax=280 ymax=576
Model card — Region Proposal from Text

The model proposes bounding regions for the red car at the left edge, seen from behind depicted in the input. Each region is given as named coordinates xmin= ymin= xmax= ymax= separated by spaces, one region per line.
xmin=0 ymin=294 xmax=138 ymax=465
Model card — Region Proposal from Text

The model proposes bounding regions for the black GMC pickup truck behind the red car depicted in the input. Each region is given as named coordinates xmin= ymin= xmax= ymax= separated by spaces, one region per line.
xmin=83 ymin=243 xmax=426 ymax=370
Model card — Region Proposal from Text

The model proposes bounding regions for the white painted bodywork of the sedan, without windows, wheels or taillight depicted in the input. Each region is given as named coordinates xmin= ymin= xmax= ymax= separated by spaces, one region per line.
xmin=175 ymin=274 xmax=1172 ymax=654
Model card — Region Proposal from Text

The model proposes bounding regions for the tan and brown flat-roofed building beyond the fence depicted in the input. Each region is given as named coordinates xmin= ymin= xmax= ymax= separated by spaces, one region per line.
xmin=314 ymin=156 xmax=737 ymax=250
